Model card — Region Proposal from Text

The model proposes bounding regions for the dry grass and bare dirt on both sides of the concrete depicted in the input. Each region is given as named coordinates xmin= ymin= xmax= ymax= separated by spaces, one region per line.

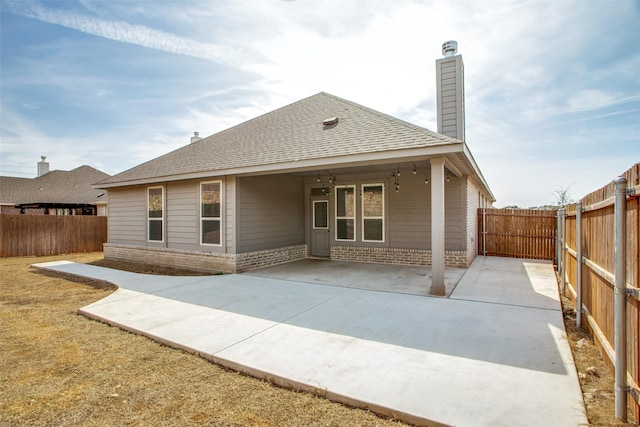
xmin=0 ymin=253 xmax=634 ymax=426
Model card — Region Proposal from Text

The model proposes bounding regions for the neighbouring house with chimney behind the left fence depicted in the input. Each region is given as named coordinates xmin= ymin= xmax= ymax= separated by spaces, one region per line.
xmin=0 ymin=156 xmax=109 ymax=215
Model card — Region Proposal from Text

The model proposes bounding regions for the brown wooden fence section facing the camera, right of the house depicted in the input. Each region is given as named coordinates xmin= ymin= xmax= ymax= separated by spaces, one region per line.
xmin=478 ymin=208 xmax=558 ymax=260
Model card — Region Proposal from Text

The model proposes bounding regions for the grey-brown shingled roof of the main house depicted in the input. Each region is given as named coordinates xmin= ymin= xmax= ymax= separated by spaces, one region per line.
xmin=97 ymin=92 xmax=463 ymax=188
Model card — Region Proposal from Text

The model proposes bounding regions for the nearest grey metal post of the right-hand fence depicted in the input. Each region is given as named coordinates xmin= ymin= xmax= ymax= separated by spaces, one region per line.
xmin=613 ymin=176 xmax=627 ymax=422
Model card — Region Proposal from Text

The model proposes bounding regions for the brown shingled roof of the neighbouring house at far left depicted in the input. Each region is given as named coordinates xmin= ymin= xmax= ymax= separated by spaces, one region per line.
xmin=0 ymin=165 xmax=109 ymax=205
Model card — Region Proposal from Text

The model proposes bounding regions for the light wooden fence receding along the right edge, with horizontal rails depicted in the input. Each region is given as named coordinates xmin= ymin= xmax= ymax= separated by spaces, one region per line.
xmin=558 ymin=163 xmax=640 ymax=420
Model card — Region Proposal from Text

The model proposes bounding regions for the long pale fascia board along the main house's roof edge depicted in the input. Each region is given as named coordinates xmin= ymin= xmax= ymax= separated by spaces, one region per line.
xmin=92 ymin=141 xmax=464 ymax=189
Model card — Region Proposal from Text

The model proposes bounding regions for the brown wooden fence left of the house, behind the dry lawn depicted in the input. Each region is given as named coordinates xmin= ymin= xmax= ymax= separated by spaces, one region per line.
xmin=0 ymin=214 xmax=107 ymax=257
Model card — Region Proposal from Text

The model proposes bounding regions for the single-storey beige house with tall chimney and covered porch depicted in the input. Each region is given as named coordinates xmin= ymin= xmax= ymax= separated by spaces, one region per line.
xmin=96 ymin=43 xmax=494 ymax=290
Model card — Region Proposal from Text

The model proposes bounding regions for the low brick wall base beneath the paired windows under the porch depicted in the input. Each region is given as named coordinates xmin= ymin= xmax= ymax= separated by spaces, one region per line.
xmin=330 ymin=246 xmax=468 ymax=268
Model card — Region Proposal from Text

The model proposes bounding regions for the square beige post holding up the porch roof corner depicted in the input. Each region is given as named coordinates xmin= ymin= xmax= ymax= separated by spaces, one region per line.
xmin=430 ymin=157 xmax=446 ymax=295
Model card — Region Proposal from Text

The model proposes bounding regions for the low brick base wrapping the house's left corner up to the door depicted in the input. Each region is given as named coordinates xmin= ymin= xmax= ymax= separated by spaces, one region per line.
xmin=104 ymin=243 xmax=307 ymax=273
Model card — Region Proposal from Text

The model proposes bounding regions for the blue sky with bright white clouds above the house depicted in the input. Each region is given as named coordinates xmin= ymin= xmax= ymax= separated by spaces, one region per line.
xmin=0 ymin=0 xmax=640 ymax=208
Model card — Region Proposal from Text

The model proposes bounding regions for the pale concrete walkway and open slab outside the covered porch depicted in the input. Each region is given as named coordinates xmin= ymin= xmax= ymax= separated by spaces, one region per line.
xmin=34 ymin=257 xmax=588 ymax=426
